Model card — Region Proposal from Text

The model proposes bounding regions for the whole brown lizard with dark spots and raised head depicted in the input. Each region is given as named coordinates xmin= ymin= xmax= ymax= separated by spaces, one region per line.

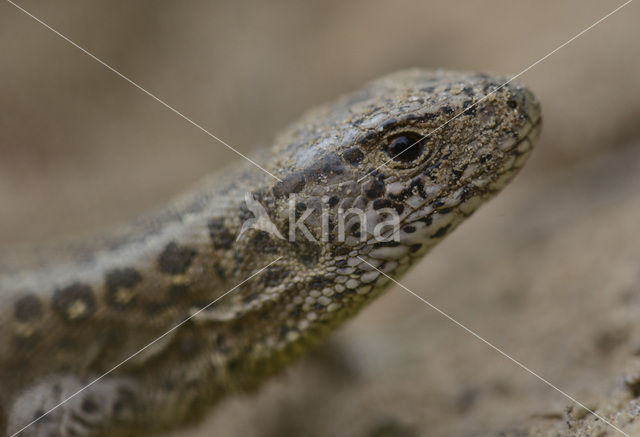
xmin=0 ymin=69 xmax=541 ymax=437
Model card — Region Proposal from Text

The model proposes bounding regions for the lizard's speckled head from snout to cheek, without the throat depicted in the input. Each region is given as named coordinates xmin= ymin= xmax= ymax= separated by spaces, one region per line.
xmin=264 ymin=70 xmax=541 ymax=272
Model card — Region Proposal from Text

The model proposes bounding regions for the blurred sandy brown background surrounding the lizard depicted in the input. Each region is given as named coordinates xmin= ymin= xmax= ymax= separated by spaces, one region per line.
xmin=0 ymin=0 xmax=640 ymax=437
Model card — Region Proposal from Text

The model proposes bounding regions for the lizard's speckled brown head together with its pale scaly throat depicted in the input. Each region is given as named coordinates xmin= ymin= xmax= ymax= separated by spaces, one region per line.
xmin=222 ymin=70 xmax=540 ymax=364
